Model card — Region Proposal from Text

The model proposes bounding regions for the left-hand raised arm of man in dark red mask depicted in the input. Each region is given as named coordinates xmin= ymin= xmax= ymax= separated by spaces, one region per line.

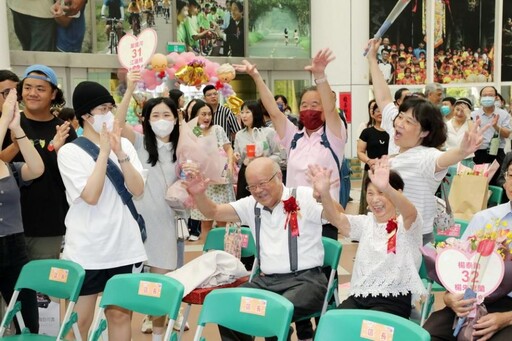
xmin=233 ymin=59 xmax=288 ymax=139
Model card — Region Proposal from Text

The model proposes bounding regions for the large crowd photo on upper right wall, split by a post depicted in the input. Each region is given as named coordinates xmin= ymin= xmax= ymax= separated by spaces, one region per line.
xmin=369 ymin=0 xmax=495 ymax=85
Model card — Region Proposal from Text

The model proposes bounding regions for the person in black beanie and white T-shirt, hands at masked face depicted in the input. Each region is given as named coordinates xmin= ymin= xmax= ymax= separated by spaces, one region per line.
xmin=57 ymin=81 xmax=147 ymax=340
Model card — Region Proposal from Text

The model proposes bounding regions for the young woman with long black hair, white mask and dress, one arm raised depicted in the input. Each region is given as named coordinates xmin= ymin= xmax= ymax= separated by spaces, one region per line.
xmin=116 ymin=72 xmax=186 ymax=340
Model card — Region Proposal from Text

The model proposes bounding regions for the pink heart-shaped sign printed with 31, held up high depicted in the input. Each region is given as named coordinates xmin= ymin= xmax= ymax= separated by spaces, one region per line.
xmin=117 ymin=28 xmax=157 ymax=71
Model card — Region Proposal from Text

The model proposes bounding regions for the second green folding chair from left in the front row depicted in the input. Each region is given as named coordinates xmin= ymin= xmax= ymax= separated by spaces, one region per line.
xmin=89 ymin=273 xmax=184 ymax=341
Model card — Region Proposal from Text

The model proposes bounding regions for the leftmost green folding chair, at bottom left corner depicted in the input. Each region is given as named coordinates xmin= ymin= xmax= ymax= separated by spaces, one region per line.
xmin=0 ymin=259 xmax=85 ymax=340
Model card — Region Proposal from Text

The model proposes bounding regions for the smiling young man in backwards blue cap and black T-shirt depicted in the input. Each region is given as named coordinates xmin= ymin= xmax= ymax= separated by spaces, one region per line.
xmin=10 ymin=65 xmax=76 ymax=259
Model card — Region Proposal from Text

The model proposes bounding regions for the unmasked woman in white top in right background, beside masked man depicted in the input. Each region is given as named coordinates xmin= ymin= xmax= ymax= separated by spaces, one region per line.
xmin=445 ymin=97 xmax=474 ymax=166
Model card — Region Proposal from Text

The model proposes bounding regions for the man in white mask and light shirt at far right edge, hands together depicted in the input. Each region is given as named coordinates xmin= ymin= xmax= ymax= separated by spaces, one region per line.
xmin=471 ymin=86 xmax=511 ymax=185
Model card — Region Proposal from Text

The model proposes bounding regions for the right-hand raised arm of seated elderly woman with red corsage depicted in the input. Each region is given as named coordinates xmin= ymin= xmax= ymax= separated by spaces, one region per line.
xmin=368 ymin=155 xmax=418 ymax=230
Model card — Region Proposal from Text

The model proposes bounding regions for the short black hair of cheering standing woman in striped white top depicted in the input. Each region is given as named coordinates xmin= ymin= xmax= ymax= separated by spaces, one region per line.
xmin=393 ymin=95 xmax=447 ymax=148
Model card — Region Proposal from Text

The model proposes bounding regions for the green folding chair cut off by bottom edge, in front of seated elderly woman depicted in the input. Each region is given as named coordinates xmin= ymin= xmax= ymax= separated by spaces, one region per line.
xmin=315 ymin=309 xmax=430 ymax=341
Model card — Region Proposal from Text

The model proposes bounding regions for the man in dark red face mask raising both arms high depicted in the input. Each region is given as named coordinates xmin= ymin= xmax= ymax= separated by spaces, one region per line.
xmin=233 ymin=49 xmax=347 ymax=340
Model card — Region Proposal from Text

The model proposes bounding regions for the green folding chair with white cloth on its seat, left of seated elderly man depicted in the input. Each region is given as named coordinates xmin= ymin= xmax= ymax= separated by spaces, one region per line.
xmin=179 ymin=226 xmax=258 ymax=340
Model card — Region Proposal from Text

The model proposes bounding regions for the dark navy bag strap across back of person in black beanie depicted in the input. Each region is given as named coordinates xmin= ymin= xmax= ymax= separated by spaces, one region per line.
xmin=72 ymin=137 xmax=148 ymax=242
